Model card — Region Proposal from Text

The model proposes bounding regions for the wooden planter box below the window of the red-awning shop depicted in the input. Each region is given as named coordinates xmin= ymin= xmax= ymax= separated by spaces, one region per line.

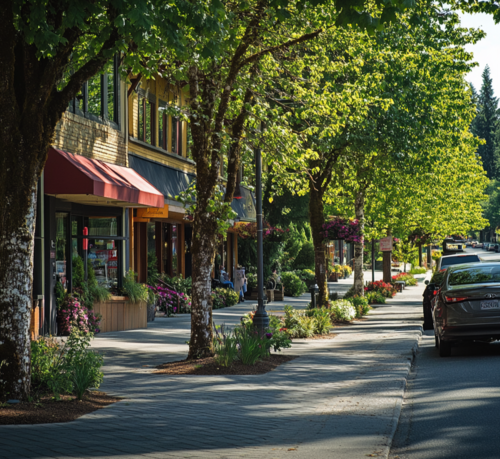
xmin=94 ymin=296 xmax=148 ymax=333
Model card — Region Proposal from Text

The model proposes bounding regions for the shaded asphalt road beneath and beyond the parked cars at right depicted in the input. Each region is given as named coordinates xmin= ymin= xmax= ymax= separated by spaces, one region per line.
xmin=389 ymin=249 xmax=500 ymax=459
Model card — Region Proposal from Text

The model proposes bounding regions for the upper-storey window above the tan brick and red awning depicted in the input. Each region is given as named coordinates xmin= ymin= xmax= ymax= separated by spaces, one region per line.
xmin=69 ymin=56 xmax=120 ymax=129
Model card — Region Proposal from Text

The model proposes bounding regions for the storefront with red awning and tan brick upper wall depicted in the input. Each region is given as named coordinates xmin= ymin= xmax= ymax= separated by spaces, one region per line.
xmin=33 ymin=59 xmax=163 ymax=334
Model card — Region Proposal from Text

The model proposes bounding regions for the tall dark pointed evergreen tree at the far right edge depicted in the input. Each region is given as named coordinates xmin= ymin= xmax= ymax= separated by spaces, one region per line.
xmin=471 ymin=65 xmax=500 ymax=179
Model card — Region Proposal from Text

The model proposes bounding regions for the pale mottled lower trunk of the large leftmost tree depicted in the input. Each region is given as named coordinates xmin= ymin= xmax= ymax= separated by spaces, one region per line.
xmin=0 ymin=187 xmax=36 ymax=399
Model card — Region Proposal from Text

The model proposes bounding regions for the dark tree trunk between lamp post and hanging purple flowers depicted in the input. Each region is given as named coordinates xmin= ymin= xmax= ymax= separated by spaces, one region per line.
xmin=309 ymin=182 xmax=328 ymax=307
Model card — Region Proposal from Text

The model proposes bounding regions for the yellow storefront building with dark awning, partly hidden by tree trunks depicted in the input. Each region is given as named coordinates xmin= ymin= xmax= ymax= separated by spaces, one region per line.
xmin=128 ymin=78 xmax=255 ymax=282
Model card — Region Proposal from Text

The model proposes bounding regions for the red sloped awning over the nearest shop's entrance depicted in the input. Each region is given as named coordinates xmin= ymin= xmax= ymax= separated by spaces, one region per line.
xmin=44 ymin=147 xmax=165 ymax=208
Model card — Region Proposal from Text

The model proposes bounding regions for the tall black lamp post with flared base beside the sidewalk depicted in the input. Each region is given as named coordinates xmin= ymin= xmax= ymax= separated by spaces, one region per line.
xmin=253 ymin=126 xmax=269 ymax=335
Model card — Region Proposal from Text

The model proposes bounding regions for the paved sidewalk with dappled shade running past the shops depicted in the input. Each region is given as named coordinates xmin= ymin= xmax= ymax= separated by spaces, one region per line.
xmin=0 ymin=279 xmax=423 ymax=459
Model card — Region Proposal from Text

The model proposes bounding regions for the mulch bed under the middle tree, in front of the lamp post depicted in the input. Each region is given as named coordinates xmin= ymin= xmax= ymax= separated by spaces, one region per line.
xmin=153 ymin=354 xmax=297 ymax=376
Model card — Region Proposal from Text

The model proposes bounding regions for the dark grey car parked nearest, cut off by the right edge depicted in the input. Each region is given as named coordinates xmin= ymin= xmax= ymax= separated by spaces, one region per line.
xmin=432 ymin=262 xmax=500 ymax=357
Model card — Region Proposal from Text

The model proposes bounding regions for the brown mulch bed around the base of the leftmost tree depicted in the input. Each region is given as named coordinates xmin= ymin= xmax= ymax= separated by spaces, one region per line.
xmin=0 ymin=391 xmax=122 ymax=425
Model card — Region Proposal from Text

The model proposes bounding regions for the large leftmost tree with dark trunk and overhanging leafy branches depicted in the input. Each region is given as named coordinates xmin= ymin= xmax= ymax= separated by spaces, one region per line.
xmin=0 ymin=0 xmax=222 ymax=398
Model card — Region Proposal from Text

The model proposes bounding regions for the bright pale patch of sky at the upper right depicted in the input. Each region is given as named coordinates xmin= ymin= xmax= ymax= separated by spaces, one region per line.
xmin=460 ymin=14 xmax=500 ymax=97
